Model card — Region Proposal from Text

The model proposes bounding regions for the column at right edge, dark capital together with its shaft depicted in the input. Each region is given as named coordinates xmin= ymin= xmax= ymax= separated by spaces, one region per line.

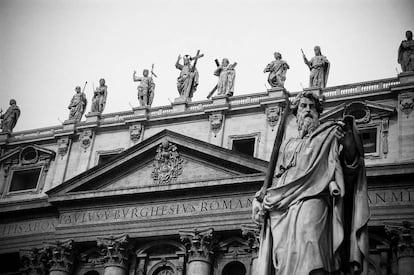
xmin=385 ymin=222 xmax=414 ymax=275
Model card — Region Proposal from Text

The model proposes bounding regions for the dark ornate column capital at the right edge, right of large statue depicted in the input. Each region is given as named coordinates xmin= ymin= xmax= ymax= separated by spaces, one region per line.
xmin=385 ymin=221 xmax=414 ymax=258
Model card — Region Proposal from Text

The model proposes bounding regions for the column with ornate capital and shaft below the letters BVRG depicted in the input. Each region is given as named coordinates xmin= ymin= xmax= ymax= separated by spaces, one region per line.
xmin=97 ymin=234 xmax=128 ymax=275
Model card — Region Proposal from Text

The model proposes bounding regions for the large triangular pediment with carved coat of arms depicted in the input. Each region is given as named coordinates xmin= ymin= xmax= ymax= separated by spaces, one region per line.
xmin=47 ymin=130 xmax=267 ymax=197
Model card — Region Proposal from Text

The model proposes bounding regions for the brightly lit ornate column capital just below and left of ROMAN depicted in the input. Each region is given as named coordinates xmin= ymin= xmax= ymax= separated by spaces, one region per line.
xmin=179 ymin=228 xmax=214 ymax=263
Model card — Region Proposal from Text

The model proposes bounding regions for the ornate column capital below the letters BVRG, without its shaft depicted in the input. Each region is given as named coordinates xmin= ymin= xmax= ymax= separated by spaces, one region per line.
xmin=97 ymin=234 xmax=129 ymax=269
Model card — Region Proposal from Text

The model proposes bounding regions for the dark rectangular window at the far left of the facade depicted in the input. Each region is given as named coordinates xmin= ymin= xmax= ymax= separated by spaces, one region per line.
xmin=9 ymin=168 xmax=42 ymax=192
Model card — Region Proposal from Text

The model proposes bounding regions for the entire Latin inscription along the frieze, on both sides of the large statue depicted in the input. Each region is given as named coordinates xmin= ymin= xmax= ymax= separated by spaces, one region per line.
xmin=0 ymin=189 xmax=414 ymax=238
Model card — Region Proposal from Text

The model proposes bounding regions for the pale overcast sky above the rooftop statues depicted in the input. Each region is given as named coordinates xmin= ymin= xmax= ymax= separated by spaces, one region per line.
xmin=0 ymin=0 xmax=414 ymax=132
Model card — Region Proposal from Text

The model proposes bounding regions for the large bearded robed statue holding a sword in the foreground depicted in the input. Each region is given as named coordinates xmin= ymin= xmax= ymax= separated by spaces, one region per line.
xmin=252 ymin=91 xmax=369 ymax=275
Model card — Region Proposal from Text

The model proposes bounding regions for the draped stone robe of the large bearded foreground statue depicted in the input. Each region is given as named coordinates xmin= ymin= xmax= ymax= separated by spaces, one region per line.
xmin=257 ymin=123 xmax=369 ymax=275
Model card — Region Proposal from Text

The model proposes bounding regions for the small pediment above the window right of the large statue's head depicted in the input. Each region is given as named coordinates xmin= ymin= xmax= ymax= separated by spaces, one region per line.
xmin=321 ymin=100 xmax=396 ymax=123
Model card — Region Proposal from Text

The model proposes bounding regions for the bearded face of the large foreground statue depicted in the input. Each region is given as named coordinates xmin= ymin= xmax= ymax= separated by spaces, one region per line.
xmin=296 ymin=97 xmax=319 ymax=138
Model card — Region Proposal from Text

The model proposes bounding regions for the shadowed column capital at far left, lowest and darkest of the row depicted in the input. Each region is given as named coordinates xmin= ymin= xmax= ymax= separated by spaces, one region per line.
xmin=20 ymin=248 xmax=49 ymax=275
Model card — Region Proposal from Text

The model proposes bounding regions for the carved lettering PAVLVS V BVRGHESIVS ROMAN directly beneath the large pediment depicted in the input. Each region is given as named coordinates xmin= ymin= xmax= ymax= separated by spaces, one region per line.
xmin=59 ymin=196 xmax=252 ymax=226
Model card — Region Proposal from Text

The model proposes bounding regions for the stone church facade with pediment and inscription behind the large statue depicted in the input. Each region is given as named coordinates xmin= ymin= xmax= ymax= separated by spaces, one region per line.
xmin=0 ymin=74 xmax=414 ymax=275
